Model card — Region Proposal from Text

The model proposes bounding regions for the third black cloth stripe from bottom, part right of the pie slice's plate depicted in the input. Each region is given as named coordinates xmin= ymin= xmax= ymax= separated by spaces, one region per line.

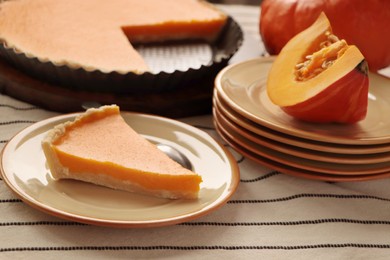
xmin=227 ymin=193 xmax=390 ymax=204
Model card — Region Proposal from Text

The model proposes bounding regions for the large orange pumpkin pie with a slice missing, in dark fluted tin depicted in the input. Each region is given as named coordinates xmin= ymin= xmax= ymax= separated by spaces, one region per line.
xmin=0 ymin=0 xmax=227 ymax=73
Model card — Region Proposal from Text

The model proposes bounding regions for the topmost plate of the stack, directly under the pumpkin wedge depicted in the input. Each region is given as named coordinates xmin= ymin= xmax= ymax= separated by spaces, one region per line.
xmin=215 ymin=57 xmax=390 ymax=145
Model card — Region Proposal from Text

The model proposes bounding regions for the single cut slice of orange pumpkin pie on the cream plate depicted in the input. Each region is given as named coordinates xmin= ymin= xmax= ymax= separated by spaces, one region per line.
xmin=42 ymin=105 xmax=202 ymax=199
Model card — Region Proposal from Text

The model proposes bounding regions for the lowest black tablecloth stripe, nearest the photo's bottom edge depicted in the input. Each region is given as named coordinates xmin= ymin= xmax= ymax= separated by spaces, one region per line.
xmin=0 ymin=243 xmax=390 ymax=252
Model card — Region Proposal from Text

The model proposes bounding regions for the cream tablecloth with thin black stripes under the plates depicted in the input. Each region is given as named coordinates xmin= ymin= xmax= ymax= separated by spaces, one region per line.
xmin=0 ymin=5 xmax=390 ymax=259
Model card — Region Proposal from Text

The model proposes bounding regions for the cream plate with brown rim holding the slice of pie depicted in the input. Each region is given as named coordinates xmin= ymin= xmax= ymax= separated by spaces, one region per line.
xmin=0 ymin=112 xmax=239 ymax=228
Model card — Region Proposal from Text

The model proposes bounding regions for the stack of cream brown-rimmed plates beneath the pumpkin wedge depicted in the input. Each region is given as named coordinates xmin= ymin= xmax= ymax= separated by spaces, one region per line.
xmin=213 ymin=58 xmax=390 ymax=181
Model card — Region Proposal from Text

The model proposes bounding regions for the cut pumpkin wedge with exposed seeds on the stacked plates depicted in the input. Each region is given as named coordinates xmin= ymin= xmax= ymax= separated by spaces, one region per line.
xmin=267 ymin=13 xmax=369 ymax=123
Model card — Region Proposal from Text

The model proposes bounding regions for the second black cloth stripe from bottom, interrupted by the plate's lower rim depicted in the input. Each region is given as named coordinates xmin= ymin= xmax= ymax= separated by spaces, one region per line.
xmin=0 ymin=218 xmax=390 ymax=227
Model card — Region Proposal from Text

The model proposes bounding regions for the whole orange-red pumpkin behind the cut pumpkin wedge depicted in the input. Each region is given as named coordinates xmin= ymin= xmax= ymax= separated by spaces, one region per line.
xmin=259 ymin=0 xmax=390 ymax=71
